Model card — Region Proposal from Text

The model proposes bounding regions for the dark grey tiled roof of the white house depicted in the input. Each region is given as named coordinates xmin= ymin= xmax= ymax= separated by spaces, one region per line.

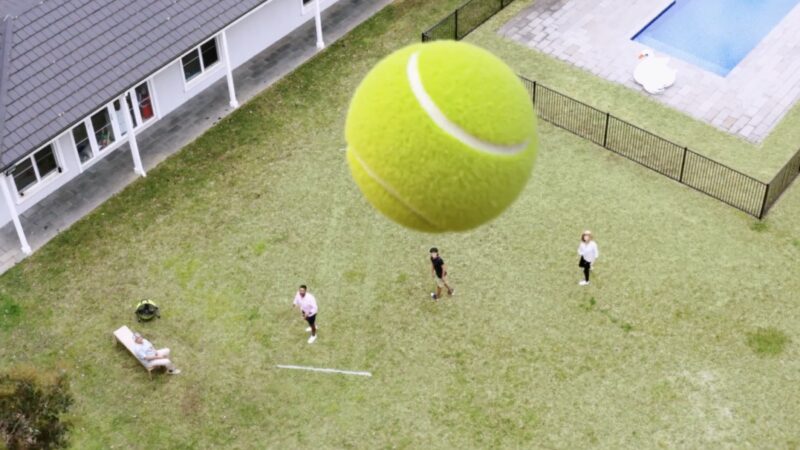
xmin=0 ymin=0 xmax=266 ymax=169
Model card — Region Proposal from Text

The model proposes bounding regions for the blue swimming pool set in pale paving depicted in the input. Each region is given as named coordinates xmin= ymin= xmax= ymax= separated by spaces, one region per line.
xmin=632 ymin=0 xmax=800 ymax=76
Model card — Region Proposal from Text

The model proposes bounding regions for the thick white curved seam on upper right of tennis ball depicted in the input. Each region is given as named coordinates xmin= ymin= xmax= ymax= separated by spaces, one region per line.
xmin=406 ymin=52 xmax=529 ymax=156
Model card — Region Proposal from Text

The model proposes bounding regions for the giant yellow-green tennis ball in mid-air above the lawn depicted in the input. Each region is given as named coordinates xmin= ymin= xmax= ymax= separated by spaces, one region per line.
xmin=345 ymin=41 xmax=537 ymax=232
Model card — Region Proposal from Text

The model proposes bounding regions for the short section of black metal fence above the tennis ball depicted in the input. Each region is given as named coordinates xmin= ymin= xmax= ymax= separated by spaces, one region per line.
xmin=422 ymin=0 xmax=514 ymax=42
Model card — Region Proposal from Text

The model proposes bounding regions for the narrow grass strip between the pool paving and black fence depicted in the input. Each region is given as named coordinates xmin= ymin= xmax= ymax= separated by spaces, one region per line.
xmin=466 ymin=0 xmax=800 ymax=182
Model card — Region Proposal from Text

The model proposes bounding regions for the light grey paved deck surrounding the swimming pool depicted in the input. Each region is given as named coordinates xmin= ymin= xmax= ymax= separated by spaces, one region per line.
xmin=499 ymin=0 xmax=800 ymax=143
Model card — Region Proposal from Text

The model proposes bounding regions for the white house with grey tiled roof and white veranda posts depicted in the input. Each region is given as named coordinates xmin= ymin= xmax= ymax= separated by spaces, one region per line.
xmin=0 ymin=0 xmax=338 ymax=254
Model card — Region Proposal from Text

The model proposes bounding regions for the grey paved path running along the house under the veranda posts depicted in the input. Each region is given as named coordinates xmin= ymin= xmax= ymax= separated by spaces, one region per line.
xmin=0 ymin=0 xmax=392 ymax=273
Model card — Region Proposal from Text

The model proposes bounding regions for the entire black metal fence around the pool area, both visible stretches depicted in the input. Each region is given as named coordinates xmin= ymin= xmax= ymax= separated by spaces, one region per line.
xmin=422 ymin=0 xmax=800 ymax=219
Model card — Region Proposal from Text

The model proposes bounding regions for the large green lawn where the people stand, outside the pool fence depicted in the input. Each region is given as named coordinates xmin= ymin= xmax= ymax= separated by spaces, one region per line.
xmin=0 ymin=0 xmax=800 ymax=449
